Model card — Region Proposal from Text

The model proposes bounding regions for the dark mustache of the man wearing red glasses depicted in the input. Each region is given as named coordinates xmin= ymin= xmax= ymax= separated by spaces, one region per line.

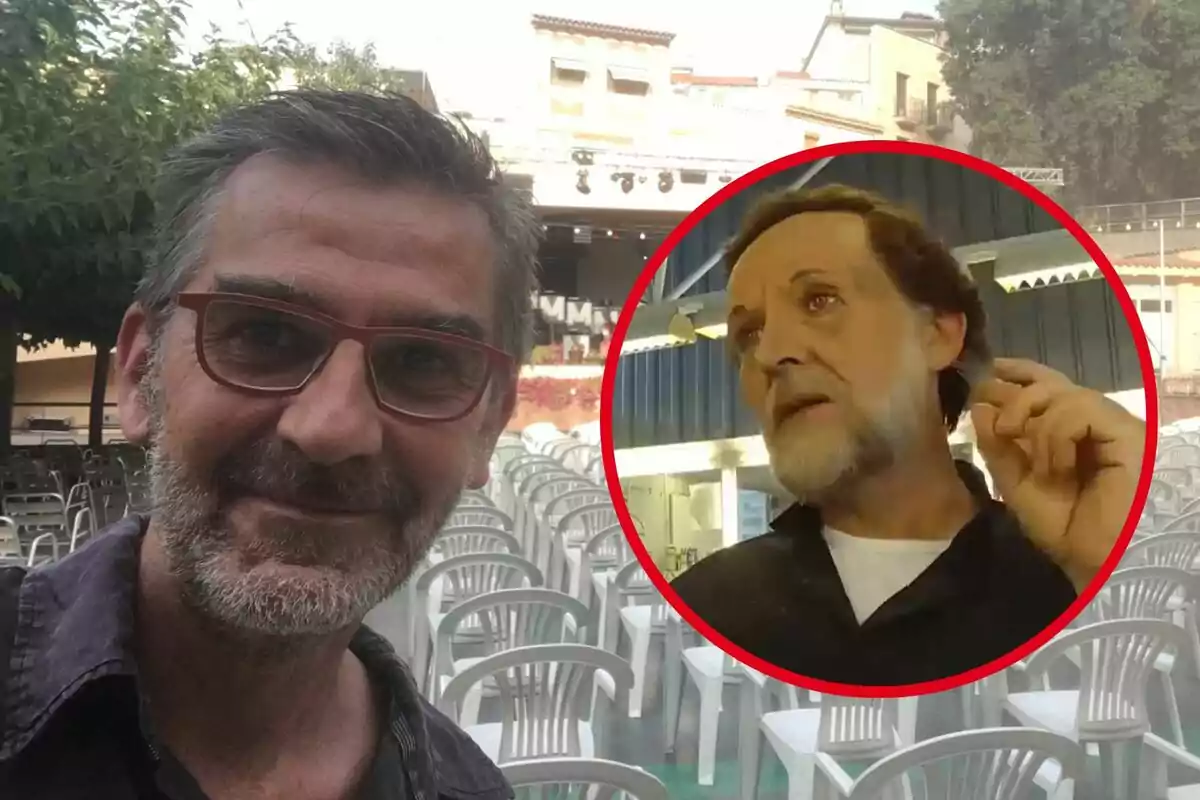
xmin=215 ymin=439 xmax=416 ymax=518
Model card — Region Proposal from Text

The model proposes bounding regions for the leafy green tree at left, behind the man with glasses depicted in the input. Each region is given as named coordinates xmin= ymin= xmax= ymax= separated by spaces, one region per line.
xmin=0 ymin=0 xmax=417 ymax=451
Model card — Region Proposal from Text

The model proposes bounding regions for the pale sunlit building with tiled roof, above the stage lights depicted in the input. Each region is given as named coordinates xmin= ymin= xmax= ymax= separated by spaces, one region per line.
xmin=472 ymin=16 xmax=883 ymax=215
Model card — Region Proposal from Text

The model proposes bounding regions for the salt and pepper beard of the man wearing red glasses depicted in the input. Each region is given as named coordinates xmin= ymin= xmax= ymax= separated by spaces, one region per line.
xmin=140 ymin=357 xmax=461 ymax=639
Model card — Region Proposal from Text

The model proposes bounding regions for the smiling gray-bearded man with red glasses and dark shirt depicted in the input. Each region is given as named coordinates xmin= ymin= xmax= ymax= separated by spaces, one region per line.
xmin=0 ymin=91 xmax=540 ymax=800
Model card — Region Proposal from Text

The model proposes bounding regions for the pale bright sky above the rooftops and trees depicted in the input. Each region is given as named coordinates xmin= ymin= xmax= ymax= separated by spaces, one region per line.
xmin=188 ymin=0 xmax=936 ymax=110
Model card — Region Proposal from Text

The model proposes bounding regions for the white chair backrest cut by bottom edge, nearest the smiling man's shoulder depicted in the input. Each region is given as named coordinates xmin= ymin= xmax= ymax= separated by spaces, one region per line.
xmin=500 ymin=758 xmax=670 ymax=800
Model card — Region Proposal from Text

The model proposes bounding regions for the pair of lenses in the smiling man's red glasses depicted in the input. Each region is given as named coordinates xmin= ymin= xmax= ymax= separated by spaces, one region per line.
xmin=202 ymin=300 xmax=491 ymax=417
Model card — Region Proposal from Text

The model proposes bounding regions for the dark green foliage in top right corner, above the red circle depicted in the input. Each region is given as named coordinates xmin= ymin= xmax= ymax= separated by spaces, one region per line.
xmin=938 ymin=0 xmax=1200 ymax=204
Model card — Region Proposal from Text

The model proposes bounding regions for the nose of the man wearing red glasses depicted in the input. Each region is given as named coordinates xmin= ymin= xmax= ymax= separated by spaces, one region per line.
xmin=278 ymin=342 xmax=383 ymax=465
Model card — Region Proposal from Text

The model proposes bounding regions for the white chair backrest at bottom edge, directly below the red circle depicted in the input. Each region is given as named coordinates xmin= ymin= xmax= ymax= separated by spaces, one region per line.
xmin=845 ymin=728 xmax=1084 ymax=800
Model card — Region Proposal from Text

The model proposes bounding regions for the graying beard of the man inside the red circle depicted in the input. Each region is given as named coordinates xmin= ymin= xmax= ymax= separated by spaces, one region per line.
xmin=767 ymin=335 xmax=929 ymax=505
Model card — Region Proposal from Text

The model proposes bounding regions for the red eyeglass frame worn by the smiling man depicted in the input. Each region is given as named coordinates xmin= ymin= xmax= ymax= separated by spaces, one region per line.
xmin=175 ymin=291 xmax=516 ymax=422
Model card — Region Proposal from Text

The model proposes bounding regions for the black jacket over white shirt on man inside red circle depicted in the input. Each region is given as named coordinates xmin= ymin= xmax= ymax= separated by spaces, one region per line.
xmin=671 ymin=464 xmax=1076 ymax=686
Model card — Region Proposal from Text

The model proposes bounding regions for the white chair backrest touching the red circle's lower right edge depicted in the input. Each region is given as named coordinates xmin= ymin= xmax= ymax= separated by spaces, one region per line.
xmin=1026 ymin=619 xmax=1189 ymax=741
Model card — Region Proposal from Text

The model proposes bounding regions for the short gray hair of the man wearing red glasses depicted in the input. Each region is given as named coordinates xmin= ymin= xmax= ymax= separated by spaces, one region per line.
xmin=134 ymin=90 xmax=541 ymax=361
